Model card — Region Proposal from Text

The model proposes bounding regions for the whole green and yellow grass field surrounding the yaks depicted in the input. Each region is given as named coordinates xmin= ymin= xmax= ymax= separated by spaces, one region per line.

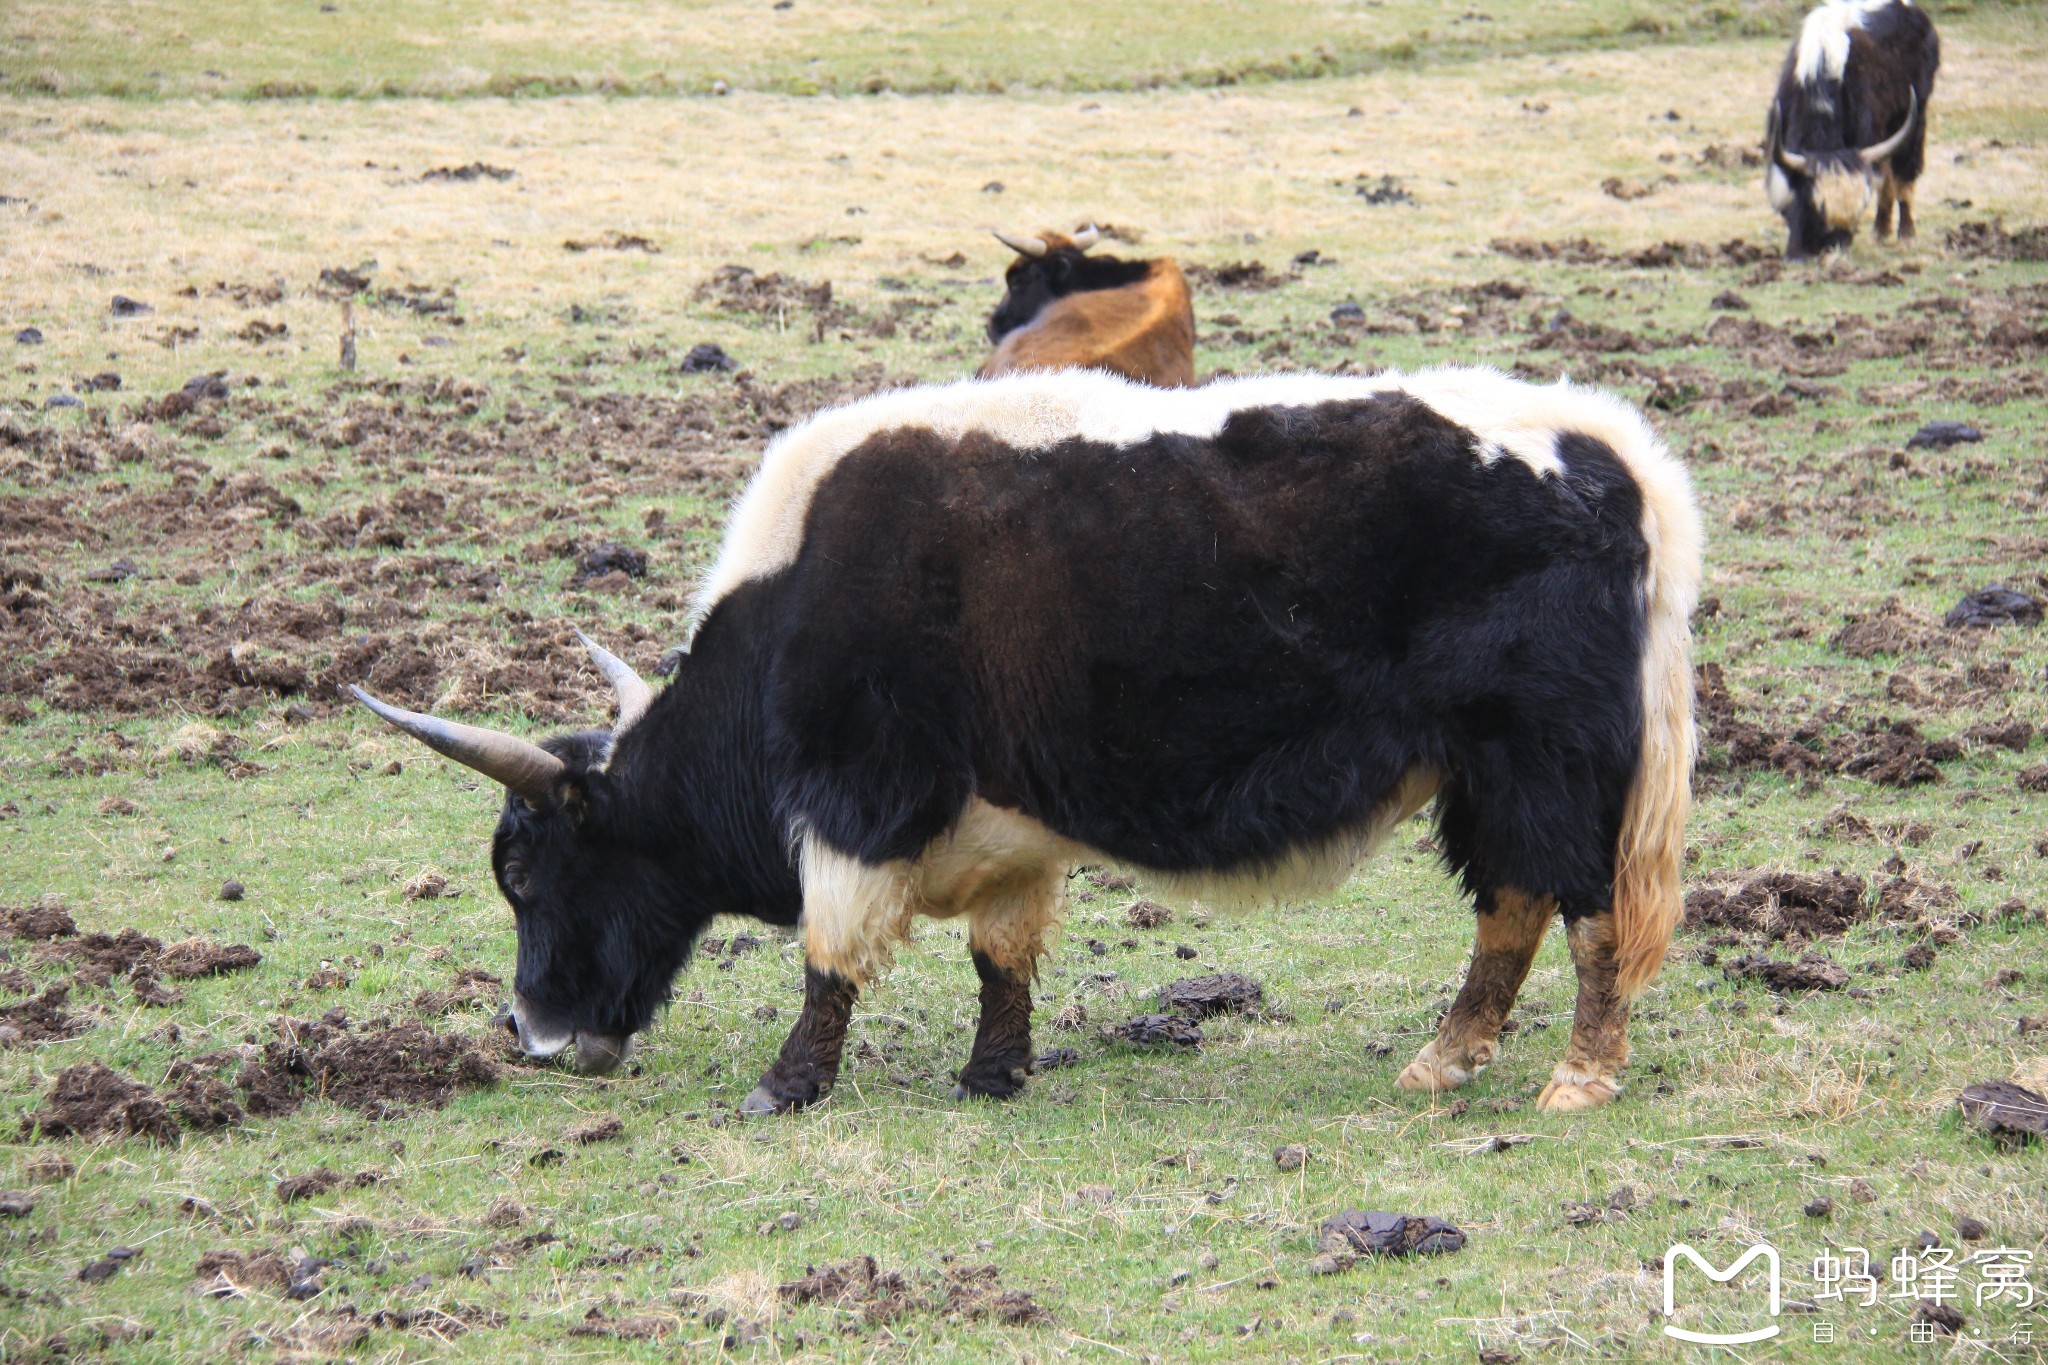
xmin=0 ymin=0 xmax=2048 ymax=1361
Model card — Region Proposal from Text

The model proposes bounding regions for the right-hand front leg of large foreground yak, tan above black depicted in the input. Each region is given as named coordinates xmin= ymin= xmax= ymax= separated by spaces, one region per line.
xmin=952 ymin=868 xmax=1065 ymax=1099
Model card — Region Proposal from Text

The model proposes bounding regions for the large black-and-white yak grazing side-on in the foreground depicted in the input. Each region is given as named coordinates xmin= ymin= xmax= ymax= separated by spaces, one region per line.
xmin=356 ymin=368 xmax=1700 ymax=1113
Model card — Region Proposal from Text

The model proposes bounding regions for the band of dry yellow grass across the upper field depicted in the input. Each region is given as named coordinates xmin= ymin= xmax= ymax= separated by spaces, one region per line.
xmin=0 ymin=23 xmax=2048 ymax=401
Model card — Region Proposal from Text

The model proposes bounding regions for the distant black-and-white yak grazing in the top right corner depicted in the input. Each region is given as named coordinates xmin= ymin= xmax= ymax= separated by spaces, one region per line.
xmin=1763 ymin=0 xmax=1942 ymax=260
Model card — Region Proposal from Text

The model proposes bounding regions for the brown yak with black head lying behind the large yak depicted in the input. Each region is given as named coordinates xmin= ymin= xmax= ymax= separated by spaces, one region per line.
xmin=981 ymin=227 xmax=1194 ymax=389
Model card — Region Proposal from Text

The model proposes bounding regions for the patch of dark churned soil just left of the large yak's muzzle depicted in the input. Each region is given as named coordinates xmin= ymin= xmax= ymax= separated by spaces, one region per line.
xmin=238 ymin=1011 xmax=502 ymax=1119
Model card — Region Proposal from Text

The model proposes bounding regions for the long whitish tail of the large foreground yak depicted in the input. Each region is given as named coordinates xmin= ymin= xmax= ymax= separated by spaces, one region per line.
xmin=1614 ymin=411 xmax=1700 ymax=999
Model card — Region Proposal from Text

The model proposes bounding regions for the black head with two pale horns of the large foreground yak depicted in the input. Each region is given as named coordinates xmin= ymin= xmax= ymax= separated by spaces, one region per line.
xmin=350 ymin=639 xmax=671 ymax=1072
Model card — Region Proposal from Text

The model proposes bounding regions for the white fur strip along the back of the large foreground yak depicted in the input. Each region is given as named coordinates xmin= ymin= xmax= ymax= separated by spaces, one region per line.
xmin=692 ymin=366 xmax=1700 ymax=630
